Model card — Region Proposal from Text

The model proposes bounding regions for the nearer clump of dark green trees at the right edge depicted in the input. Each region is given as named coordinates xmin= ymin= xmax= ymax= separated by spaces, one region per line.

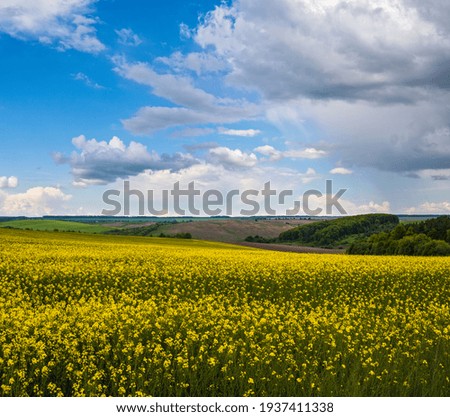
xmin=347 ymin=216 xmax=450 ymax=256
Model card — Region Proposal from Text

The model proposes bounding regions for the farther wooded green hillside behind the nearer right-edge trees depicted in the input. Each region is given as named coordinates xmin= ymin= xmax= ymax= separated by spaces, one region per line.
xmin=279 ymin=214 xmax=399 ymax=246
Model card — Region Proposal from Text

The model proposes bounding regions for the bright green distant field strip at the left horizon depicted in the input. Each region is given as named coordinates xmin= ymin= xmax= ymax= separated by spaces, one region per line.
xmin=0 ymin=219 xmax=111 ymax=233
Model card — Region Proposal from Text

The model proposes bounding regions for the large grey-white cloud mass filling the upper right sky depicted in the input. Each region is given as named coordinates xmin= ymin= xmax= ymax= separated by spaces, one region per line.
xmin=189 ymin=0 xmax=450 ymax=175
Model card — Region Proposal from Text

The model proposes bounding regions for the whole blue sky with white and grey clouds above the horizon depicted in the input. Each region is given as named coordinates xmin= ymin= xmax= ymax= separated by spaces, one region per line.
xmin=0 ymin=0 xmax=450 ymax=216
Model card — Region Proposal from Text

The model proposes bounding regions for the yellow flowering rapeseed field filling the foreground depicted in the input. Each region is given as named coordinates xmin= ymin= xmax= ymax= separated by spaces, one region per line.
xmin=0 ymin=230 xmax=450 ymax=396
